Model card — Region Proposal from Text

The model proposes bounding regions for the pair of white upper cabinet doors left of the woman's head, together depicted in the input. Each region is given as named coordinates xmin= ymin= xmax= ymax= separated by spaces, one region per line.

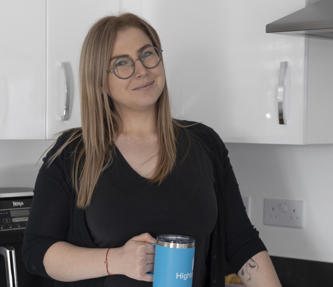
xmin=0 ymin=0 xmax=119 ymax=139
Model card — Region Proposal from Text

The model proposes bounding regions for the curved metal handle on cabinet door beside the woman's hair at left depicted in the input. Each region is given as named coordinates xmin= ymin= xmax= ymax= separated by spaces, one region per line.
xmin=61 ymin=62 xmax=74 ymax=121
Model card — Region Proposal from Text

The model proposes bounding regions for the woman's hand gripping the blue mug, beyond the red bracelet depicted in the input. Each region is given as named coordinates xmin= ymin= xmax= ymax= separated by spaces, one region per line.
xmin=110 ymin=233 xmax=156 ymax=282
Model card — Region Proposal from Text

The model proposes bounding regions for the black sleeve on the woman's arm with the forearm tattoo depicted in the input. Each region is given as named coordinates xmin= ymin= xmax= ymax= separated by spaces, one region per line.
xmin=204 ymin=125 xmax=266 ymax=273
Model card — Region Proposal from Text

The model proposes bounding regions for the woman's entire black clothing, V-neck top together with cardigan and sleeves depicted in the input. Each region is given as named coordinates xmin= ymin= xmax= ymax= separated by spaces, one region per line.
xmin=22 ymin=120 xmax=266 ymax=287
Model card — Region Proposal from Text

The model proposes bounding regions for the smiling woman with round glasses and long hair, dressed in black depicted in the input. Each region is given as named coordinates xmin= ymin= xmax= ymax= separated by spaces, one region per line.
xmin=23 ymin=14 xmax=281 ymax=287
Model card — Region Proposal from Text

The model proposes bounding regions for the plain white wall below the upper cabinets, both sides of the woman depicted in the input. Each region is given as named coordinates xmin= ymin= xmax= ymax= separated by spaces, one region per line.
xmin=0 ymin=141 xmax=333 ymax=262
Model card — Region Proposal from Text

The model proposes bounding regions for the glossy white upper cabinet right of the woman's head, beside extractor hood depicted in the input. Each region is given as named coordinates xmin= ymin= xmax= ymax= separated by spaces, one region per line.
xmin=120 ymin=0 xmax=333 ymax=144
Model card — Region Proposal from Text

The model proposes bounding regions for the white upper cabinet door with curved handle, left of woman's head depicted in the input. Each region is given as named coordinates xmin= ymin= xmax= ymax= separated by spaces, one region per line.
xmin=47 ymin=0 xmax=119 ymax=138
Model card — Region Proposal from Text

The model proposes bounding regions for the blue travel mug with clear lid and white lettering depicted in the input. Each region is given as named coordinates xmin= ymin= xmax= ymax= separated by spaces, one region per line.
xmin=148 ymin=234 xmax=195 ymax=287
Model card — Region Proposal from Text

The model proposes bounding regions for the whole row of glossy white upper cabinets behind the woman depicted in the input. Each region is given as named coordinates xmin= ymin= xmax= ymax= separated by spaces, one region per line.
xmin=0 ymin=0 xmax=333 ymax=144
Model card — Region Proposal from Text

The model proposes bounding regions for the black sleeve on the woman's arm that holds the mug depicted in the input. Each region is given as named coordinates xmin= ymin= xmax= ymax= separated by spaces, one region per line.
xmin=22 ymin=136 xmax=73 ymax=278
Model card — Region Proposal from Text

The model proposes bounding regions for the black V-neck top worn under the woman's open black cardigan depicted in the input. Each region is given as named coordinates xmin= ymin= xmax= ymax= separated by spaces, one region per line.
xmin=85 ymin=127 xmax=217 ymax=287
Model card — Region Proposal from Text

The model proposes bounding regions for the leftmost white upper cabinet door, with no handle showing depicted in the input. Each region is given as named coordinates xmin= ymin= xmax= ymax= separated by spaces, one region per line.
xmin=0 ymin=0 xmax=46 ymax=139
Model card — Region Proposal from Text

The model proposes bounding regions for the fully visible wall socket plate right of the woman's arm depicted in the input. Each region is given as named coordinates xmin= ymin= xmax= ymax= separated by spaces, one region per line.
xmin=264 ymin=198 xmax=304 ymax=228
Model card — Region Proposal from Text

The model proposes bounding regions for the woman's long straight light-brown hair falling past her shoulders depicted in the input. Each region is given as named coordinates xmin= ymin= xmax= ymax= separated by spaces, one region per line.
xmin=48 ymin=13 xmax=197 ymax=208
